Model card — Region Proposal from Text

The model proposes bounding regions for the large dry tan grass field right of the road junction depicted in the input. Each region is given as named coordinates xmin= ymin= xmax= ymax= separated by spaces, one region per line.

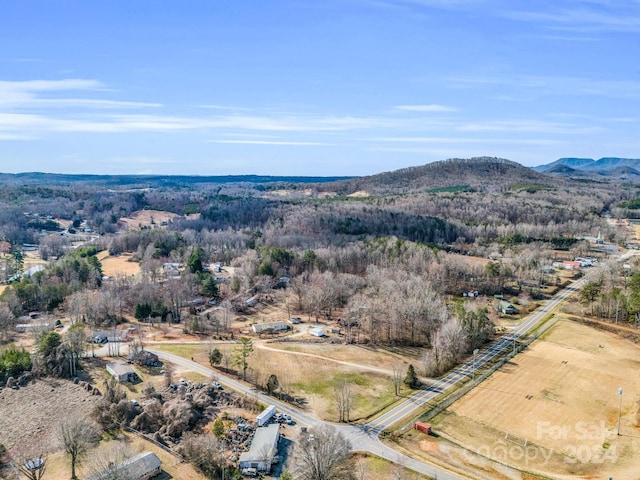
xmin=421 ymin=321 xmax=640 ymax=478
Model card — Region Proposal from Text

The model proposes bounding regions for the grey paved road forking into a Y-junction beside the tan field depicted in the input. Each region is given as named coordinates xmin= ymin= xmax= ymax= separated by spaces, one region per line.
xmin=150 ymin=278 xmax=586 ymax=480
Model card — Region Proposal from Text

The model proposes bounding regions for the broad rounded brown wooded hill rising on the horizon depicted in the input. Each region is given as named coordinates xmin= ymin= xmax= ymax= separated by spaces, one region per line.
xmin=321 ymin=157 xmax=558 ymax=195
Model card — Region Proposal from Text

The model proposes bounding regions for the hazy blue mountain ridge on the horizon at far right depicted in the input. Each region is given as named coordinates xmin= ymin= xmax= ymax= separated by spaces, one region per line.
xmin=533 ymin=157 xmax=640 ymax=181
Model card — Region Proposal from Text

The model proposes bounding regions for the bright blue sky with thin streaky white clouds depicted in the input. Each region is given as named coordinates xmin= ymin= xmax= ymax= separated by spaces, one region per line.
xmin=0 ymin=0 xmax=640 ymax=175
